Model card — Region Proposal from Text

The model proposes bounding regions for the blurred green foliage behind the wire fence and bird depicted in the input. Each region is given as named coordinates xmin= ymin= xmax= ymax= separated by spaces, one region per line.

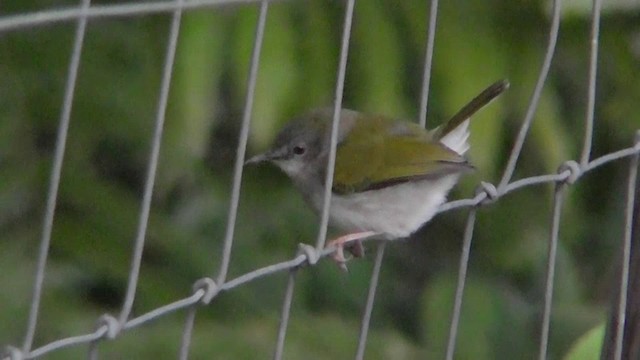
xmin=0 ymin=0 xmax=640 ymax=360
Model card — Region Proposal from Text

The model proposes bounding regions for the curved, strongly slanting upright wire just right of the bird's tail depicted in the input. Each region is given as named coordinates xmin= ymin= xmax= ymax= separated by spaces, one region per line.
xmin=498 ymin=0 xmax=562 ymax=193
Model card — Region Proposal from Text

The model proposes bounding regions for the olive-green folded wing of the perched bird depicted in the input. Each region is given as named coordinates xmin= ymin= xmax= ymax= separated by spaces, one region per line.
xmin=333 ymin=118 xmax=472 ymax=194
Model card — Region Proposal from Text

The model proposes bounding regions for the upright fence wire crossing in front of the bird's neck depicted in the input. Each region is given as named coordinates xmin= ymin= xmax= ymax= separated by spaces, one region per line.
xmin=316 ymin=0 xmax=355 ymax=251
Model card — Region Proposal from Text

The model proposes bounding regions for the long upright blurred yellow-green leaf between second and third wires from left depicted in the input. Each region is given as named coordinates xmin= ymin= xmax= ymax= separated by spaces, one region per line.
xmin=160 ymin=12 xmax=228 ymax=188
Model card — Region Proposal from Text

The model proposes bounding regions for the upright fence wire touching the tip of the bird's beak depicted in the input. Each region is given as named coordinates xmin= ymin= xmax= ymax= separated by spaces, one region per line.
xmin=217 ymin=0 xmax=269 ymax=286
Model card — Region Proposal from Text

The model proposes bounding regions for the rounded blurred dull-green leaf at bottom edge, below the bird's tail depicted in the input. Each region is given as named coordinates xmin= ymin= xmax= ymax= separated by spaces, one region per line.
xmin=422 ymin=275 xmax=535 ymax=360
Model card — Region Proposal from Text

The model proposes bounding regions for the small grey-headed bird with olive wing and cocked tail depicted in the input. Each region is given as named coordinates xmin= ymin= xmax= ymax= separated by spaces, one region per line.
xmin=245 ymin=80 xmax=509 ymax=270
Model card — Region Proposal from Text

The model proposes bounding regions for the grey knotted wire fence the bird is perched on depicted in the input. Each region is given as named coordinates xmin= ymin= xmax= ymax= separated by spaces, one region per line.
xmin=0 ymin=0 xmax=640 ymax=359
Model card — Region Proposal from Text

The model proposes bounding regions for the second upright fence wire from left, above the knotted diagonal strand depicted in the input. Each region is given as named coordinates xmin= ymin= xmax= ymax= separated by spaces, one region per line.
xmin=118 ymin=0 xmax=184 ymax=327
